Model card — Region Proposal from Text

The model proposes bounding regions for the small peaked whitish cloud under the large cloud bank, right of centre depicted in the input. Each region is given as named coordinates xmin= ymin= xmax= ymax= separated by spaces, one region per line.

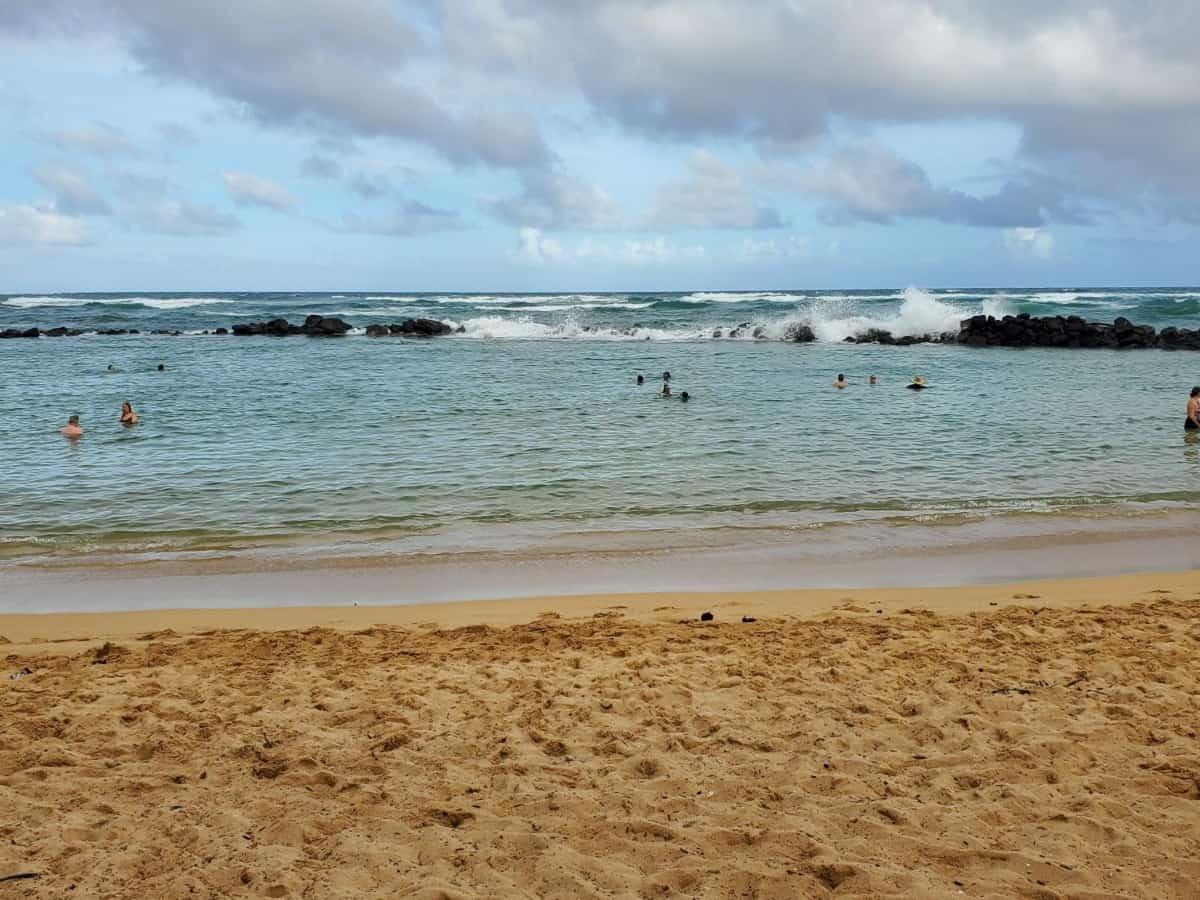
xmin=652 ymin=150 xmax=784 ymax=228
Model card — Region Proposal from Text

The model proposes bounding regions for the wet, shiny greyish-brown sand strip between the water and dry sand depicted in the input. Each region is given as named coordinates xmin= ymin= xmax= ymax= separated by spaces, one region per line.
xmin=0 ymin=514 xmax=1200 ymax=619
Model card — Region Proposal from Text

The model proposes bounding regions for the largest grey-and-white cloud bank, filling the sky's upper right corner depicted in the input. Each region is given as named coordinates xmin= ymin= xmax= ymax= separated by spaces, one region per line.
xmin=440 ymin=0 xmax=1200 ymax=207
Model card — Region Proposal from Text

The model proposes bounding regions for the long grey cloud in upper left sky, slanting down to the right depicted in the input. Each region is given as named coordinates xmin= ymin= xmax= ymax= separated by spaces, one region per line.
xmin=9 ymin=0 xmax=550 ymax=167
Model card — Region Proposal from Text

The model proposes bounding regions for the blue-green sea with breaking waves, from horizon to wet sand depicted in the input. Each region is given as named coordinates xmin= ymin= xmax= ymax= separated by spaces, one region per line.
xmin=0 ymin=289 xmax=1200 ymax=565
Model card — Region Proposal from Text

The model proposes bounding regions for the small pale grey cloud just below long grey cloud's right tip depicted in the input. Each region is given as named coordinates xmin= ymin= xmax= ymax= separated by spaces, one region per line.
xmin=490 ymin=172 xmax=626 ymax=230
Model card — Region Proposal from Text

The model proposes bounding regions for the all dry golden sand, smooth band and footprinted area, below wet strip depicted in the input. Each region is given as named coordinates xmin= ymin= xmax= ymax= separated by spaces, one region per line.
xmin=0 ymin=572 xmax=1200 ymax=898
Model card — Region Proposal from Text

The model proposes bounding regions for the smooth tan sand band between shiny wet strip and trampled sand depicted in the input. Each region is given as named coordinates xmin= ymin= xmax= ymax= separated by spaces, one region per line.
xmin=0 ymin=569 xmax=1200 ymax=654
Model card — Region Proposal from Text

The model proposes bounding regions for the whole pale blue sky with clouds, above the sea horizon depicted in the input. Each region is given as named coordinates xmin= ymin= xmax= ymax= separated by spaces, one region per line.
xmin=0 ymin=0 xmax=1200 ymax=293
